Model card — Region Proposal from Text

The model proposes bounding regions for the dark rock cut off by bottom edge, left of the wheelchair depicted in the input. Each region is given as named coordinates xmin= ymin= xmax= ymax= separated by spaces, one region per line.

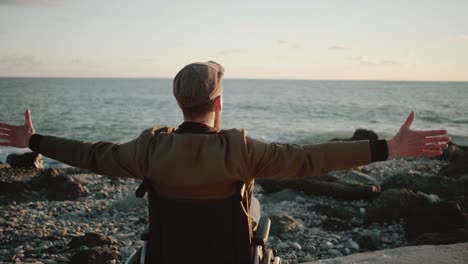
xmin=71 ymin=248 xmax=120 ymax=264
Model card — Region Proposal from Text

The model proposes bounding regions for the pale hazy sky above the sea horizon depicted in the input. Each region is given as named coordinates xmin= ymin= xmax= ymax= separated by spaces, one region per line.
xmin=0 ymin=0 xmax=468 ymax=81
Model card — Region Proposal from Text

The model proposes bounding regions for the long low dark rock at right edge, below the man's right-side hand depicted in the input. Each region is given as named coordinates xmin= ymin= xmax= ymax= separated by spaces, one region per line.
xmin=381 ymin=172 xmax=468 ymax=197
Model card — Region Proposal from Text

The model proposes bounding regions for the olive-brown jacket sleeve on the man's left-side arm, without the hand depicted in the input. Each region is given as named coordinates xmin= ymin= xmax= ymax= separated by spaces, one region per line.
xmin=32 ymin=129 xmax=153 ymax=179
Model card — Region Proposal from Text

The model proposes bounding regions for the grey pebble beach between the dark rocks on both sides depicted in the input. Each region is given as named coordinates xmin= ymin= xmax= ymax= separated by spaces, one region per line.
xmin=0 ymin=152 xmax=460 ymax=264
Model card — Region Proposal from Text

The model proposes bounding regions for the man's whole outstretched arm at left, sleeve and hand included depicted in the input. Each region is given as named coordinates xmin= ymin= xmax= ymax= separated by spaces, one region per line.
xmin=0 ymin=109 xmax=151 ymax=178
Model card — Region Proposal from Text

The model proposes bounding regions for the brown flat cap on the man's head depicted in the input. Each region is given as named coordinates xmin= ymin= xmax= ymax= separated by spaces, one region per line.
xmin=173 ymin=61 xmax=224 ymax=113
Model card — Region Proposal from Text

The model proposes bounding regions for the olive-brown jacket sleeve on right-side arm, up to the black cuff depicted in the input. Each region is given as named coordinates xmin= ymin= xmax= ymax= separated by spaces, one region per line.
xmin=245 ymin=137 xmax=371 ymax=182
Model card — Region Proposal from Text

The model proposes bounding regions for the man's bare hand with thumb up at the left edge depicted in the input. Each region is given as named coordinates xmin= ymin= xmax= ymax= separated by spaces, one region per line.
xmin=0 ymin=109 xmax=36 ymax=148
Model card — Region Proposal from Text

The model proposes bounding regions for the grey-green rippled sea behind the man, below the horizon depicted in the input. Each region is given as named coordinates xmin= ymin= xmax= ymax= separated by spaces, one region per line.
xmin=0 ymin=78 xmax=468 ymax=166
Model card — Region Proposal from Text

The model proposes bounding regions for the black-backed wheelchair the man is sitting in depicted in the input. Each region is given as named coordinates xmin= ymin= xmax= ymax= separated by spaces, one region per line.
xmin=125 ymin=180 xmax=281 ymax=264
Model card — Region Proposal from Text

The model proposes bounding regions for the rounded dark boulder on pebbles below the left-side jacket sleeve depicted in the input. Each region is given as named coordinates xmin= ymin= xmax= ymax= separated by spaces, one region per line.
xmin=46 ymin=175 xmax=88 ymax=201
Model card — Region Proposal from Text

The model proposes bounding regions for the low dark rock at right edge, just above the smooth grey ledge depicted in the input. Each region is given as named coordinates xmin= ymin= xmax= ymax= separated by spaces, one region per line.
xmin=409 ymin=229 xmax=468 ymax=245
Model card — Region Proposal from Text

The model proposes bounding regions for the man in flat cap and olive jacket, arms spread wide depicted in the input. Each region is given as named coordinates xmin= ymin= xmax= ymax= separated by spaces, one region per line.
xmin=0 ymin=61 xmax=450 ymax=260
